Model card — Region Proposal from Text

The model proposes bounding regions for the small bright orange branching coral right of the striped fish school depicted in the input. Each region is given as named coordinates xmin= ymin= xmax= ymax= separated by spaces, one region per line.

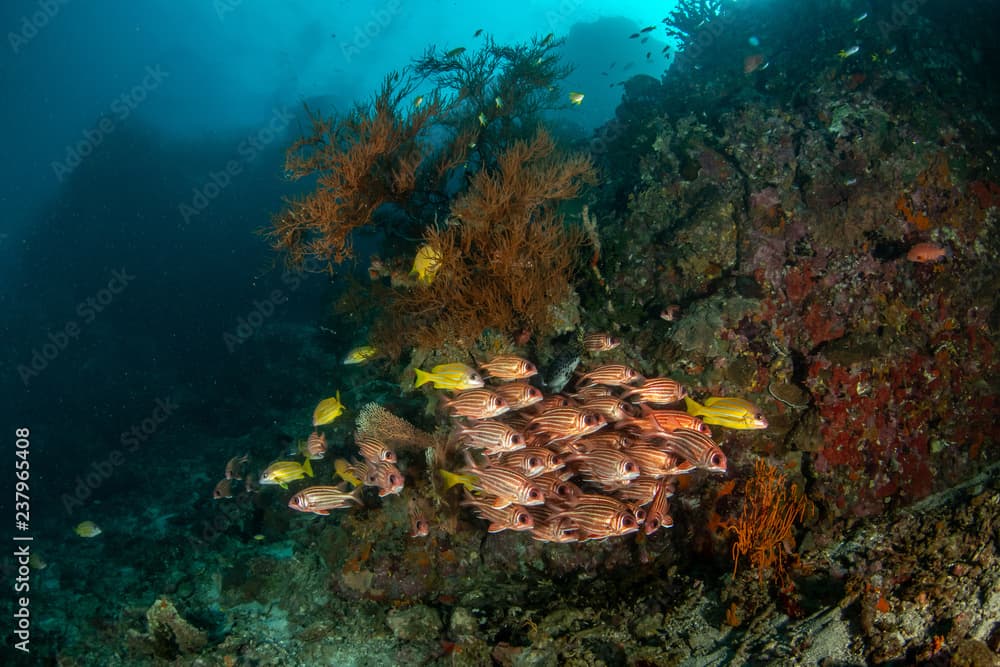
xmin=729 ymin=459 xmax=811 ymax=581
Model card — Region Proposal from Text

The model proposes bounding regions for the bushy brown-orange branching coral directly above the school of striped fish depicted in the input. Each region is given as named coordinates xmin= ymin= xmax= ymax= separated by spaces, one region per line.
xmin=380 ymin=130 xmax=593 ymax=347
